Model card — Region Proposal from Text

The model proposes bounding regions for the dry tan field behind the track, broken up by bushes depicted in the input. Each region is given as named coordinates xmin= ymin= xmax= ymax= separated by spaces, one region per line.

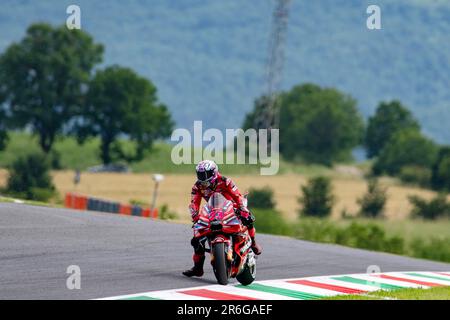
xmin=0 ymin=170 xmax=433 ymax=220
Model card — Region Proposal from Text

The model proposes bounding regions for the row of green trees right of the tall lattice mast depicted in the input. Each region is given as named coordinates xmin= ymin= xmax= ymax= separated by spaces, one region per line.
xmin=243 ymin=84 xmax=450 ymax=190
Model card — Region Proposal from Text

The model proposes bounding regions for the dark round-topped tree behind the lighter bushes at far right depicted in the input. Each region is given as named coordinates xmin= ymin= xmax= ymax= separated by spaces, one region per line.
xmin=365 ymin=100 xmax=420 ymax=158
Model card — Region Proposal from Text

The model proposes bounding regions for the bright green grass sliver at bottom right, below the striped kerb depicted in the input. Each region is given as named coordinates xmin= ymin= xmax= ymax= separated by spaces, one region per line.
xmin=323 ymin=287 xmax=450 ymax=300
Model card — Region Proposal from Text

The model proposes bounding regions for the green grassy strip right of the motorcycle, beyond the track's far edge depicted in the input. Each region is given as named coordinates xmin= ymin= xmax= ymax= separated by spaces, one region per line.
xmin=253 ymin=209 xmax=450 ymax=262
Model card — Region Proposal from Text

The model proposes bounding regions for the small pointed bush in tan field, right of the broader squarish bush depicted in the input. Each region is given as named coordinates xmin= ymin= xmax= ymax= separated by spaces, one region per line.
xmin=357 ymin=179 xmax=387 ymax=218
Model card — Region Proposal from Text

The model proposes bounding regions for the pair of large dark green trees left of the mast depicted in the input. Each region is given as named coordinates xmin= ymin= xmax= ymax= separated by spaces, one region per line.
xmin=0 ymin=23 xmax=173 ymax=164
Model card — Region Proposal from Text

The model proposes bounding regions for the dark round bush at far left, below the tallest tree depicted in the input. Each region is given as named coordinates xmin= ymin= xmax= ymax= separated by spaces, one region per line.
xmin=5 ymin=153 xmax=55 ymax=201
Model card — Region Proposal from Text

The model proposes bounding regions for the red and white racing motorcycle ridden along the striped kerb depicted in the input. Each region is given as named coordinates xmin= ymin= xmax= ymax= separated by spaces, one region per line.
xmin=194 ymin=192 xmax=256 ymax=285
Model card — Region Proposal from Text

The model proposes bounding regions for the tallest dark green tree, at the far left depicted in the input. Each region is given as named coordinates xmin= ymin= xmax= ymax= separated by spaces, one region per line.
xmin=0 ymin=23 xmax=103 ymax=153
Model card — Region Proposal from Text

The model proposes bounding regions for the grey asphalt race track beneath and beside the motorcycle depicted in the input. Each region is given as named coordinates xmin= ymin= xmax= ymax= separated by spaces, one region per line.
xmin=0 ymin=203 xmax=450 ymax=299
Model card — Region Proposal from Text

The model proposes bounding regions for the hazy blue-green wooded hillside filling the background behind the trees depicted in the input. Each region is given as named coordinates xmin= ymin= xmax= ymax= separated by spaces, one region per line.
xmin=0 ymin=0 xmax=450 ymax=143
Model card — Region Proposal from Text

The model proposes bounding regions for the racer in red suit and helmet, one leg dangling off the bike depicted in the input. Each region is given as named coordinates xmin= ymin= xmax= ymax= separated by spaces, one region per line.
xmin=183 ymin=160 xmax=262 ymax=277
